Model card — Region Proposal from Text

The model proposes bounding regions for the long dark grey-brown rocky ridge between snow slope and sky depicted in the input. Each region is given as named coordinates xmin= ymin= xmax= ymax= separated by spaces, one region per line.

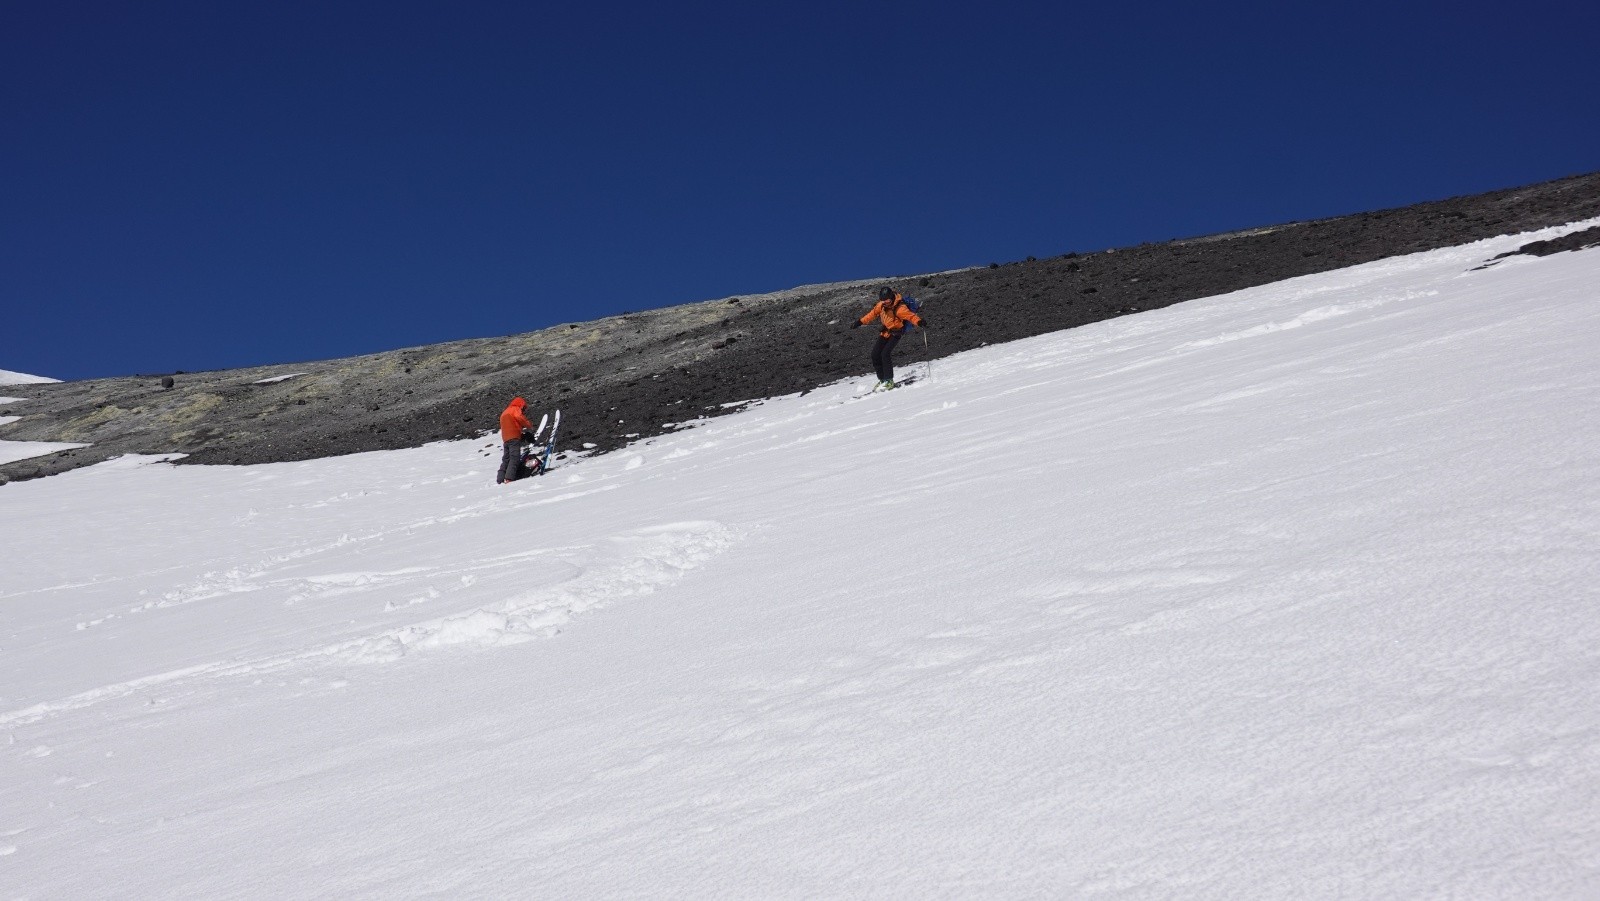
xmin=0 ymin=173 xmax=1600 ymax=480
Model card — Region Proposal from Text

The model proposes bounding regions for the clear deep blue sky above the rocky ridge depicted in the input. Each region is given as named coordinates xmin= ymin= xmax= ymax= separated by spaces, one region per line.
xmin=0 ymin=0 xmax=1600 ymax=379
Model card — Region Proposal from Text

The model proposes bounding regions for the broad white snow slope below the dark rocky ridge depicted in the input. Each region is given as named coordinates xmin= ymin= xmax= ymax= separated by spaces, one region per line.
xmin=0 ymin=226 xmax=1600 ymax=899
